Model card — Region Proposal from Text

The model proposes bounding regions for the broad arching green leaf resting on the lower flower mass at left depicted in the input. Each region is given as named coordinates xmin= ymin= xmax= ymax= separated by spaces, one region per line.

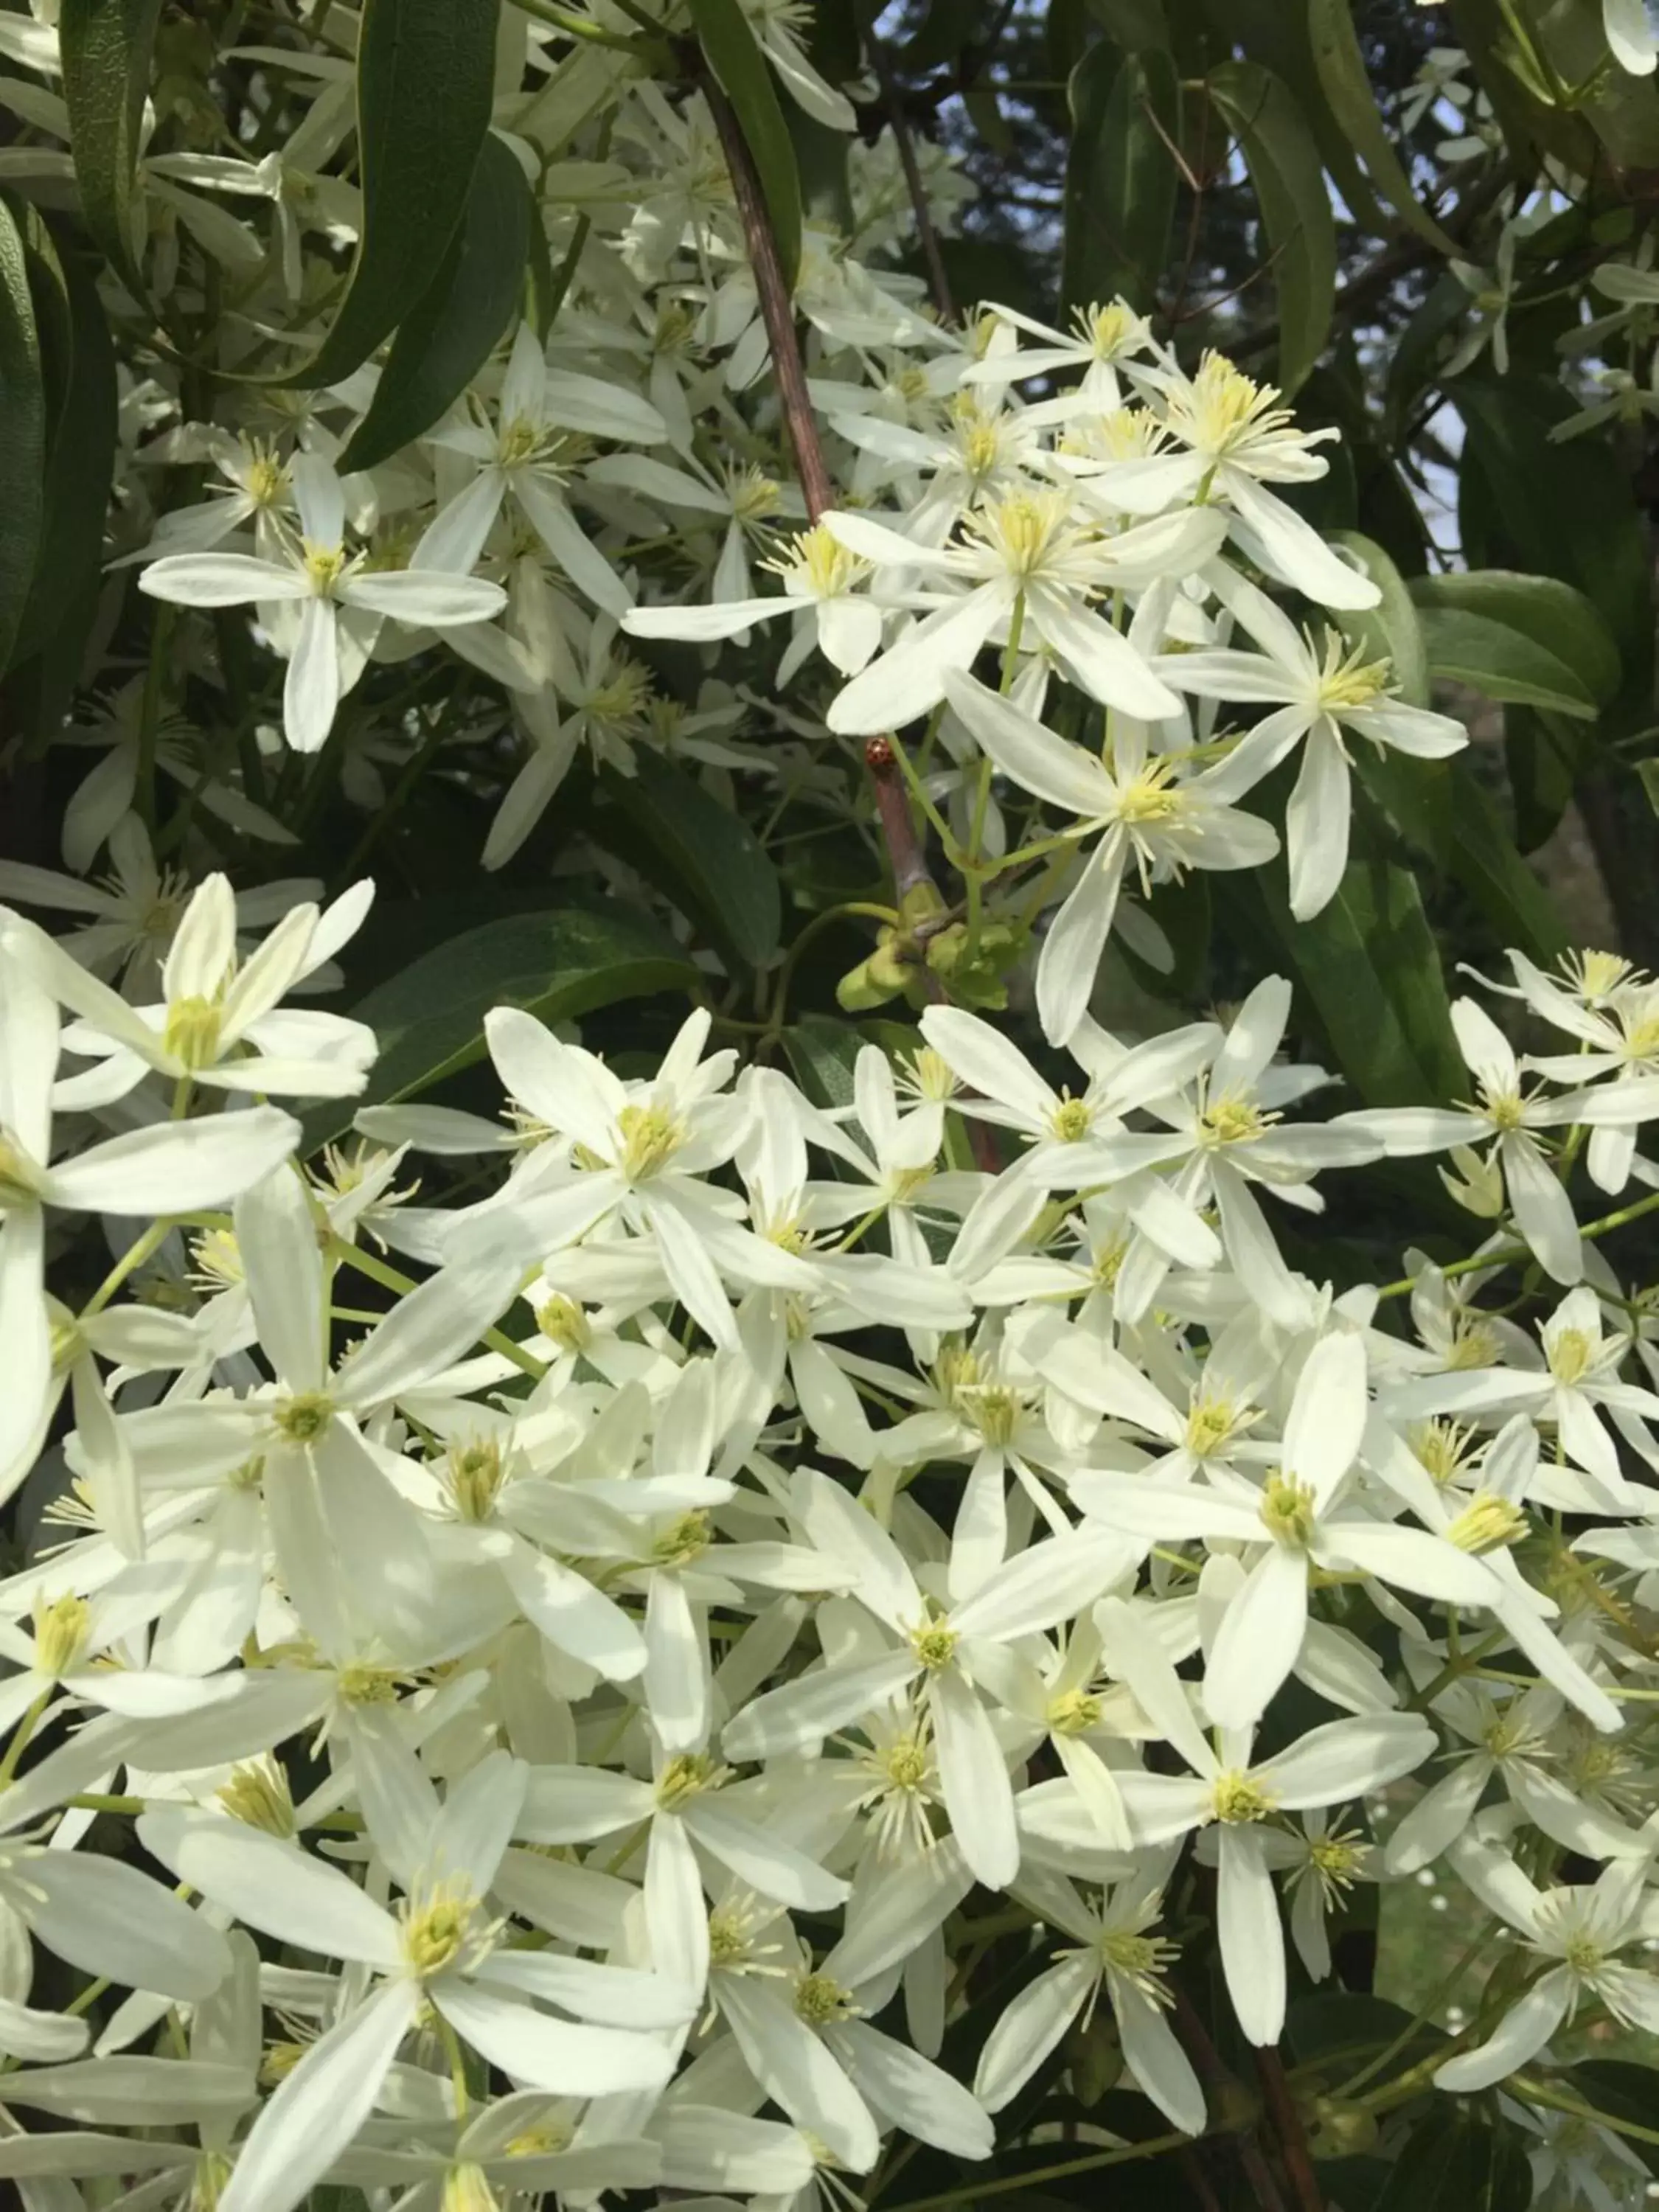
xmin=305 ymin=907 xmax=697 ymax=1146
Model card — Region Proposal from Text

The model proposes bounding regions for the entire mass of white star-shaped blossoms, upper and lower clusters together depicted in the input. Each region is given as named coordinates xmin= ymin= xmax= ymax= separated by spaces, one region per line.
xmin=0 ymin=0 xmax=1659 ymax=2212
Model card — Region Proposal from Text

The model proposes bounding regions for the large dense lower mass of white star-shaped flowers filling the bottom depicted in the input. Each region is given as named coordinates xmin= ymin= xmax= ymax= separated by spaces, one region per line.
xmin=0 ymin=854 xmax=1659 ymax=2212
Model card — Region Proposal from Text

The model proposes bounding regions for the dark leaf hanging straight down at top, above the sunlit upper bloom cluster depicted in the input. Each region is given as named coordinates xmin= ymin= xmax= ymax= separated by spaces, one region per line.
xmin=1062 ymin=40 xmax=1181 ymax=307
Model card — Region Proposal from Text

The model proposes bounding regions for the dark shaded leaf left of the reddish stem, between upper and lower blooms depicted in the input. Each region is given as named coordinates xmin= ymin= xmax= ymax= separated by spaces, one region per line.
xmin=604 ymin=757 xmax=783 ymax=969
